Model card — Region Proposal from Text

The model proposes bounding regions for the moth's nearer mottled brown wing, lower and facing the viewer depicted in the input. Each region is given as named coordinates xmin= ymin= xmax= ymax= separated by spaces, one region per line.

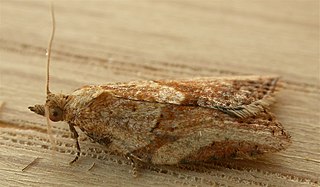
xmin=76 ymin=82 xmax=289 ymax=164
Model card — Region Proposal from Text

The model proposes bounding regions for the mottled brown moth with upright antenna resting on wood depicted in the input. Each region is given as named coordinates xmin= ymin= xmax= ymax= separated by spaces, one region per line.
xmin=29 ymin=5 xmax=290 ymax=175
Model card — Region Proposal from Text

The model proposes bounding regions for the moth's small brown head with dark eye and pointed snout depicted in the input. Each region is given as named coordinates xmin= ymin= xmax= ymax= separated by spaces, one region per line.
xmin=28 ymin=93 xmax=69 ymax=122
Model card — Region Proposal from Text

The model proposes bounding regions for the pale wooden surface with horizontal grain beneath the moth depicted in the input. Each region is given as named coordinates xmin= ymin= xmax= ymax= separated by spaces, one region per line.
xmin=0 ymin=0 xmax=320 ymax=186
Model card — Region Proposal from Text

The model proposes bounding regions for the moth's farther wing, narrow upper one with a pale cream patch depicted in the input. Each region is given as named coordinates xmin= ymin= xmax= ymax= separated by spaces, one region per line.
xmin=101 ymin=76 xmax=278 ymax=118
